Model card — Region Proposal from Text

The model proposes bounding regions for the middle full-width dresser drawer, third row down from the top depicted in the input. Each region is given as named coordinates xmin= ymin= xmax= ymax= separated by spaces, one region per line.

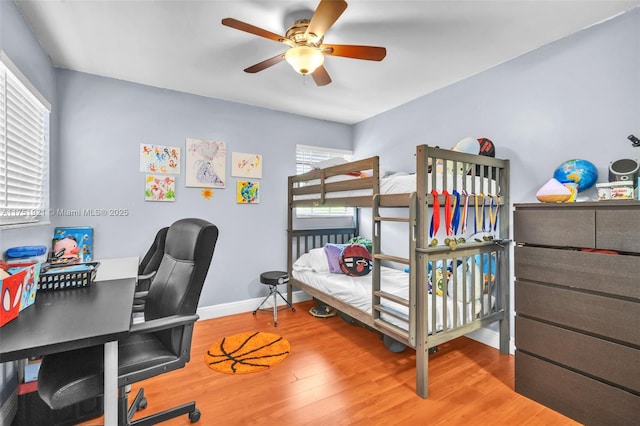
xmin=515 ymin=279 xmax=640 ymax=345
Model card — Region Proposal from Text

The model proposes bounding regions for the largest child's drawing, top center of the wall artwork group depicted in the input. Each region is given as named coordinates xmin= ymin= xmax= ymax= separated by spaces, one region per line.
xmin=185 ymin=138 xmax=227 ymax=188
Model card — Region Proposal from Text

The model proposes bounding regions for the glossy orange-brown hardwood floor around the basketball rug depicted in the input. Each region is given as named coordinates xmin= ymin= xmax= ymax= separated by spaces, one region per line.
xmin=83 ymin=302 xmax=577 ymax=426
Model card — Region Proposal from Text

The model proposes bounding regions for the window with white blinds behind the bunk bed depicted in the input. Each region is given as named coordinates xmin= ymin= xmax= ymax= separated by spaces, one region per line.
xmin=296 ymin=145 xmax=354 ymax=217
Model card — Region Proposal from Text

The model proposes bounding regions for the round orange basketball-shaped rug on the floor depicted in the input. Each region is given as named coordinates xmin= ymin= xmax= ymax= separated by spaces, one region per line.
xmin=204 ymin=331 xmax=291 ymax=374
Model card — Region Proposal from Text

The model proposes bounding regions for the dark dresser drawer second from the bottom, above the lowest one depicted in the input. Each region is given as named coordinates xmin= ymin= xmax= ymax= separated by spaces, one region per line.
xmin=516 ymin=317 xmax=640 ymax=393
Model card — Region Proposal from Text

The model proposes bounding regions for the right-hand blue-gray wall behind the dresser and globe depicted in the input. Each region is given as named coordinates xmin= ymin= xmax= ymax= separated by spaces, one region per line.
xmin=354 ymin=8 xmax=640 ymax=345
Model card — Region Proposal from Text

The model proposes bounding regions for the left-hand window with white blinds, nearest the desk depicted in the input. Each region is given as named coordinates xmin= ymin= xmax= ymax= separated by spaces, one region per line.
xmin=0 ymin=52 xmax=50 ymax=225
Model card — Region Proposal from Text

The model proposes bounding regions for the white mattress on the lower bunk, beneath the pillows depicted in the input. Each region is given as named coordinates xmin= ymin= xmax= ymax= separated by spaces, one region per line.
xmin=293 ymin=249 xmax=488 ymax=333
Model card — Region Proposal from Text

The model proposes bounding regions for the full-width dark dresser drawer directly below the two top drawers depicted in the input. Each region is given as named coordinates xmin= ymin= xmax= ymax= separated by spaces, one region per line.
xmin=514 ymin=246 xmax=640 ymax=302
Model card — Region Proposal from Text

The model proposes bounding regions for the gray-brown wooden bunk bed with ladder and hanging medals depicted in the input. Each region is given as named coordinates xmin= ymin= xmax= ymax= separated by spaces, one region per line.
xmin=287 ymin=145 xmax=510 ymax=398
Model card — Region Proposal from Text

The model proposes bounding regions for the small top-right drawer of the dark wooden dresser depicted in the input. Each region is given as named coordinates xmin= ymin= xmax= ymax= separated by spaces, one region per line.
xmin=596 ymin=209 xmax=640 ymax=252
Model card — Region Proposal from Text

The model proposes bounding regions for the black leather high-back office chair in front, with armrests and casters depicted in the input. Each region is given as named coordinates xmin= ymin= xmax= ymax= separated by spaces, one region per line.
xmin=38 ymin=219 xmax=218 ymax=425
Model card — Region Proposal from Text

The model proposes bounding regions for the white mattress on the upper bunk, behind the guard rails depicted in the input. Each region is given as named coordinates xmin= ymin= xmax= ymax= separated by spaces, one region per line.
xmin=294 ymin=173 xmax=499 ymax=200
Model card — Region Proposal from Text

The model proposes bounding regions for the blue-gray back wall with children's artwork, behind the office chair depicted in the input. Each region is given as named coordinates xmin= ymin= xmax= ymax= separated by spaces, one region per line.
xmin=52 ymin=70 xmax=352 ymax=307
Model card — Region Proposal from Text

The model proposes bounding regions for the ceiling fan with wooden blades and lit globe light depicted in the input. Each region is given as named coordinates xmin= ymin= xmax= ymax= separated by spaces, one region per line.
xmin=222 ymin=0 xmax=387 ymax=86
